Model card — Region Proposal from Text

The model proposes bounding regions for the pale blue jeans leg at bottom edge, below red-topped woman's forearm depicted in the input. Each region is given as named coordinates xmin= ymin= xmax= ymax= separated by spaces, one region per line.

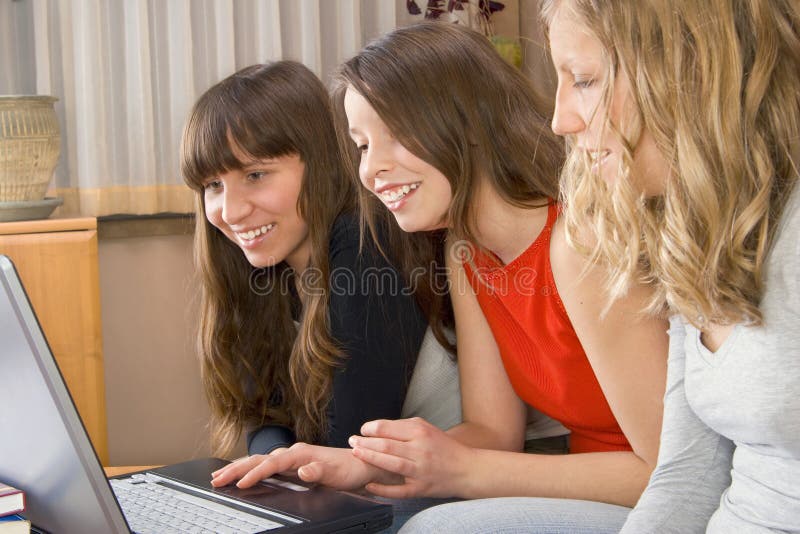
xmin=401 ymin=497 xmax=630 ymax=534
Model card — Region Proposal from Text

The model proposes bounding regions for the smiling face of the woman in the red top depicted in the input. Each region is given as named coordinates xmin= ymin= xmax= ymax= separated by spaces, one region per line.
xmin=344 ymin=88 xmax=453 ymax=232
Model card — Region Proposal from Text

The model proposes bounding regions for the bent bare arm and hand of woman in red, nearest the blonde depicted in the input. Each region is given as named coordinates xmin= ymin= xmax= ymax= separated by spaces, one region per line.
xmin=351 ymin=224 xmax=668 ymax=506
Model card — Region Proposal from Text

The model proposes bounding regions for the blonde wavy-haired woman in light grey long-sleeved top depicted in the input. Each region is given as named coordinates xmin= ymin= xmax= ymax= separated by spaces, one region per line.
xmin=482 ymin=0 xmax=800 ymax=534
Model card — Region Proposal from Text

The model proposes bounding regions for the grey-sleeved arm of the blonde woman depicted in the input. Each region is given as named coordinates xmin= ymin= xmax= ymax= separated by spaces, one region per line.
xmin=621 ymin=317 xmax=733 ymax=534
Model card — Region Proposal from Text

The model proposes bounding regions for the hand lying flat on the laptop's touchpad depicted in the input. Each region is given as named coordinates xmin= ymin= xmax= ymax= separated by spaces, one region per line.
xmin=211 ymin=443 xmax=390 ymax=490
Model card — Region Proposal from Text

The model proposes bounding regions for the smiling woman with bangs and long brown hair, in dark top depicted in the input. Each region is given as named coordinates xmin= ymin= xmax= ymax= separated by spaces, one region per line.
xmin=181 ymin=61 xmax=459 ymax=462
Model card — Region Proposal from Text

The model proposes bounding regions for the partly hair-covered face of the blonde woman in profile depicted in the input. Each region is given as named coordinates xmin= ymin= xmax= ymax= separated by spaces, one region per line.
xmin=550 ymin=8 xmax=668 ymax=196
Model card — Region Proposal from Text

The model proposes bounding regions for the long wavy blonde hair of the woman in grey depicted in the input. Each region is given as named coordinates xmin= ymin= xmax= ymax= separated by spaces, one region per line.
xmin=541 ymin=0 xmax=800 ymax=328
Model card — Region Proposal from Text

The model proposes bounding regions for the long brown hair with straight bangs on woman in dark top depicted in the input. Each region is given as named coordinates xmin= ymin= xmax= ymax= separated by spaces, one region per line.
xmin=181 ymin=61 xmax=355 ymax=454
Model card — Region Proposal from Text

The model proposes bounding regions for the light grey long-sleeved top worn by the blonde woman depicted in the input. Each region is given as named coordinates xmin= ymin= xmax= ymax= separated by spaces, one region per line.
xmin=622 ymin=189 xmax=800 ymax=534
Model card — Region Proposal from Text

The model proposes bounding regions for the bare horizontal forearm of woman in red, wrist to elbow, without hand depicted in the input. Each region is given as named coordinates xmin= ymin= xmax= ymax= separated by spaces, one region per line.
xmin=458 ymin=449 xmax=652 ymax=507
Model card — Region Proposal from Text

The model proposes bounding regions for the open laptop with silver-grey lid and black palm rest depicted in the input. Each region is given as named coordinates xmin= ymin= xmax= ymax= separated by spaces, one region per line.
xmin=0 ymin=255 xmax=392 ymax=534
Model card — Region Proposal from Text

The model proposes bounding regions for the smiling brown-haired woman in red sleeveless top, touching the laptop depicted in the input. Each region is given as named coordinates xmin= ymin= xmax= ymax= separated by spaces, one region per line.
xmin=214 ymin=24 xmax=667 ymax=531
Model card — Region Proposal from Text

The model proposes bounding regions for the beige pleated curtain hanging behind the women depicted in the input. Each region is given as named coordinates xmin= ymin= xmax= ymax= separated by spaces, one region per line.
xmin=0 ymin=0 xmax=405 ymax=216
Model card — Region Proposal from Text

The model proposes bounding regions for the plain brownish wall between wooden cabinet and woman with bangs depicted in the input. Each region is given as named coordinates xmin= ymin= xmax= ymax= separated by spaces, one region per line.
xmin=99 ymin=228 xmax=219 ymax=465
